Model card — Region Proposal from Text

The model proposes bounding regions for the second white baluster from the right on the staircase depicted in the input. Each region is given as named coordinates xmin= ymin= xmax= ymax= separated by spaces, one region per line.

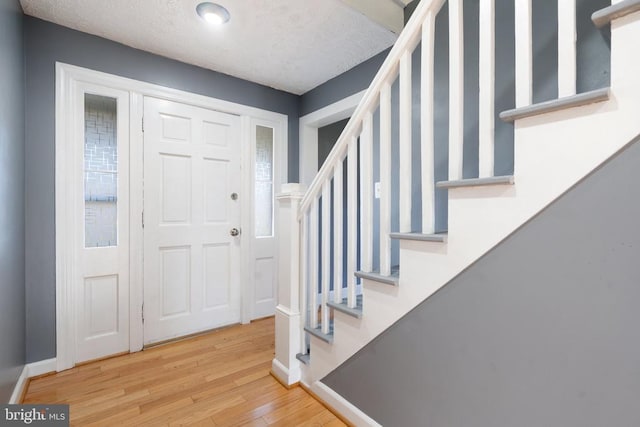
xmin=515 ymin=0 xmax=532 ymax=108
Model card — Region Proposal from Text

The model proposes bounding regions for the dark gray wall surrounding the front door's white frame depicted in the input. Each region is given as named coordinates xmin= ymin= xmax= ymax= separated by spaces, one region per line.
xmin=25 ymin=17 xmax=300 ymax=362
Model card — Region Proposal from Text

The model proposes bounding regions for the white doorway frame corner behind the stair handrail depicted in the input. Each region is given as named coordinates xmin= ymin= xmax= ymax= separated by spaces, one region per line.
xmin=299 ymin=90 xmax=366 ymax=187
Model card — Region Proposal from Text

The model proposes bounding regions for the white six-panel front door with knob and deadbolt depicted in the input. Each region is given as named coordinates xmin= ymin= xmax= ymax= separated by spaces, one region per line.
xmin=143 ymin=97 xmax=242 ymax=344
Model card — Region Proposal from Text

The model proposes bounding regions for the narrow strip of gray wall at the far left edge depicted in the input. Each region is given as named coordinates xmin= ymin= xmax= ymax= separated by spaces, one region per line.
xmin=0 ymin=0 xmax=25 ymax=403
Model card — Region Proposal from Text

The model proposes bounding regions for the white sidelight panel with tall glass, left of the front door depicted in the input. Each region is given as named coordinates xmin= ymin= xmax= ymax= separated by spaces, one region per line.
xmin=75 ymin=83 xmax=129 ymax=362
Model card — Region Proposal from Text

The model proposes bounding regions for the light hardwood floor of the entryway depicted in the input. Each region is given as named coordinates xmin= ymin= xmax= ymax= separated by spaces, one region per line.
xmin=24 ymin=318 xmax=345 ymax=427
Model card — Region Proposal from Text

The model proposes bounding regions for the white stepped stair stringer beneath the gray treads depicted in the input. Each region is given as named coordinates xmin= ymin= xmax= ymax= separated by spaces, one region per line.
xmin=303 ymin=12 xmax=640 ymax=384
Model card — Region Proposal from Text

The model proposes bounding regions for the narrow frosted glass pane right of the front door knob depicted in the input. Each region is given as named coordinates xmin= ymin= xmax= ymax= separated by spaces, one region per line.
xmin=255 ymin=126 xmax=273 ymax=237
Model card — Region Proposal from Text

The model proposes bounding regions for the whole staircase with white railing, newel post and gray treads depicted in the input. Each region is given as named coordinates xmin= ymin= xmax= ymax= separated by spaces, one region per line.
xmin=273 ymin=0 xmax=640 ymax=425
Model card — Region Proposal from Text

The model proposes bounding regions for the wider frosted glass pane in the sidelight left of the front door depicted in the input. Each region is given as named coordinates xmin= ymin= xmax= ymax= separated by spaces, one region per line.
xmin=84 ymin=94 xmax=118 ymax=248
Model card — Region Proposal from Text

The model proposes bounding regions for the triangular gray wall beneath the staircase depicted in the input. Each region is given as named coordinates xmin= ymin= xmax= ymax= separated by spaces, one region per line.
xmin=323 ymin=138 xmax=640 ymax=427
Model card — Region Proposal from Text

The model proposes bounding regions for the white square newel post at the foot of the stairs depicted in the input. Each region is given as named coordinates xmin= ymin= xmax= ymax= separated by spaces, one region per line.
xmin=271 ymin=184 xmax=305 ymax=385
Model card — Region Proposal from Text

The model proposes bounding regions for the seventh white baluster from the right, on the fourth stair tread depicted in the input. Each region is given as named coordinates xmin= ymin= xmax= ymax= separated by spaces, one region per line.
xmin=380 ymin=82 xmax=391 ymax=276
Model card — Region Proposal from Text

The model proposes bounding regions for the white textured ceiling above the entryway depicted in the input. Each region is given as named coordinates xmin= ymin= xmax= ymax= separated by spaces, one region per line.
xmin=21 ymin=0 xmax=403 ymax=95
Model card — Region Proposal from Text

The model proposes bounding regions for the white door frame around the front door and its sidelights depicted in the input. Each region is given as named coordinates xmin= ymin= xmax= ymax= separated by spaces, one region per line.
xmin=55 ymin=62 xmax=288 ymax=371
